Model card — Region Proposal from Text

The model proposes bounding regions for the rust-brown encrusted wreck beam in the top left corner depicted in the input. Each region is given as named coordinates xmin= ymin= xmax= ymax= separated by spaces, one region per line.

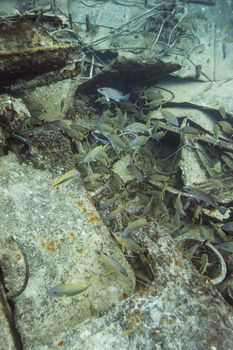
xmin=0 ymin=15 xmax=78 ymax=87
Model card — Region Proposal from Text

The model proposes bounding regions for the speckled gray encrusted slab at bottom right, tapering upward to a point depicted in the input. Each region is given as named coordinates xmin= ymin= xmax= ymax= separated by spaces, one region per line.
xmin=45 ymin=225 xmax=233 ymax=350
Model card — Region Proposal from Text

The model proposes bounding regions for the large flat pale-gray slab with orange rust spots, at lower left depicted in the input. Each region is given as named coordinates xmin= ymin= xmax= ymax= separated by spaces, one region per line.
xmin=0 ymin=155 xmax=135 ymax=349
